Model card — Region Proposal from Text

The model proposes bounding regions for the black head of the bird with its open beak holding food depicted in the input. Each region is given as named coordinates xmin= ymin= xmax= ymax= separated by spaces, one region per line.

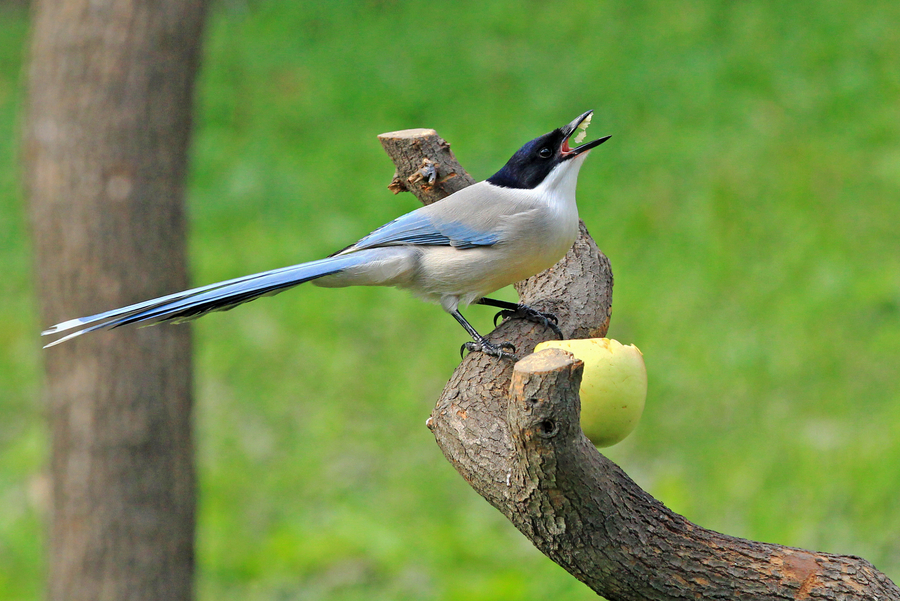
xmin=487 ymin=111 xmax=610 ymax=189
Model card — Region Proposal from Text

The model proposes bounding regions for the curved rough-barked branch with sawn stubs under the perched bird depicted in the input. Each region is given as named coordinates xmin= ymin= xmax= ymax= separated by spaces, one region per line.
xmin=376 ymin=130 xmax=900 ymax=601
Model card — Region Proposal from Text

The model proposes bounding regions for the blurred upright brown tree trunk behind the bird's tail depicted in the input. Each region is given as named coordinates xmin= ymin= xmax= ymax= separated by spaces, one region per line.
xmin=24 ymin=0 xmax=204 ymax=601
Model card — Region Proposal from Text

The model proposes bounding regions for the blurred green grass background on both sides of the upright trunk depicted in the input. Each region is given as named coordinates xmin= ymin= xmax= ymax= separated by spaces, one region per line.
xmin=0 ymin=0 xmax=900 ymax=600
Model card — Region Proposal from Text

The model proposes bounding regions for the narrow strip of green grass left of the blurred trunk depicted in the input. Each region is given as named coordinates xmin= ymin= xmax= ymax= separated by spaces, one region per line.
xmin=0 ymin=3 xmax=43 ymax=599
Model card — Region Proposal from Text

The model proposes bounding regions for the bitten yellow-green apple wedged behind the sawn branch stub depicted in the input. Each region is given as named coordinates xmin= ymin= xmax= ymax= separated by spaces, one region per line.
xmin=534 ymin=338 xmax=647 ymax=447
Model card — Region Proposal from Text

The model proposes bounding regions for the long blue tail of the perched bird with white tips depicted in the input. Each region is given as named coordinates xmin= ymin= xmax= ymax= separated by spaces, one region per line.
xmin=41 ymin=252 xmax=368 ymax=348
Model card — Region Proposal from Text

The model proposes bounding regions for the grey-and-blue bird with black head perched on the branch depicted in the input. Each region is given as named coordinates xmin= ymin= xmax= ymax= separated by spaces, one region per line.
xmin=41 ymin=110 xmax=611 ymax=359
